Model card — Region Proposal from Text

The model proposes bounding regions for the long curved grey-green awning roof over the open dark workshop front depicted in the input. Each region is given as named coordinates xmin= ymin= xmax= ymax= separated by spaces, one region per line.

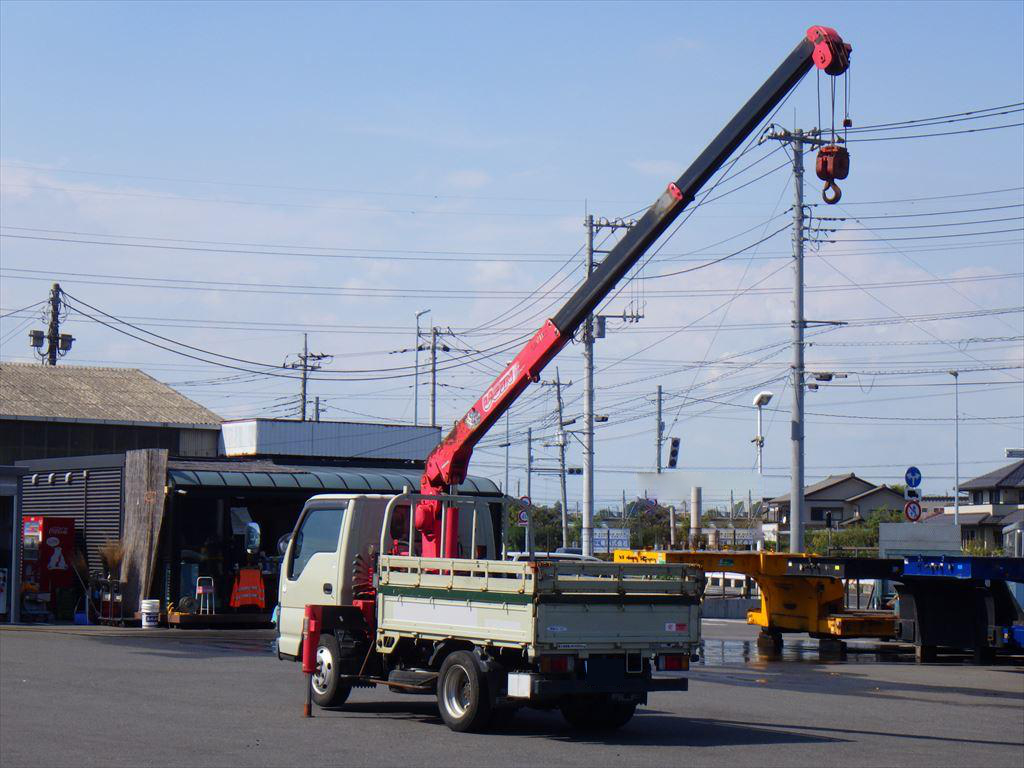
xmin=167 ymin=460 xmax=502 ymax=496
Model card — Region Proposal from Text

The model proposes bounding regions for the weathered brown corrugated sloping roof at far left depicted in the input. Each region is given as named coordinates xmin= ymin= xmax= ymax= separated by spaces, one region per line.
xmin=0 ymin=362 xmax=220 ymax=429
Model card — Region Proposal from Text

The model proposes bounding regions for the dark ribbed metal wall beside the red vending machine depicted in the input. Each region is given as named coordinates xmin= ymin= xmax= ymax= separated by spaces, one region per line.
xmin=22 ymin=467 xmax=122 ymax=570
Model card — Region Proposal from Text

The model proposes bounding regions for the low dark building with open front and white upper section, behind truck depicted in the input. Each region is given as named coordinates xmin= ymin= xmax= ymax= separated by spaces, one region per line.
xmin=12 ymin=420 xmax=503 ymax=624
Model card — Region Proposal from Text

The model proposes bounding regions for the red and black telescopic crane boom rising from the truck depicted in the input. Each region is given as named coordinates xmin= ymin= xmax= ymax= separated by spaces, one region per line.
xmin=416 ymin=27 xmax=852 ymax=557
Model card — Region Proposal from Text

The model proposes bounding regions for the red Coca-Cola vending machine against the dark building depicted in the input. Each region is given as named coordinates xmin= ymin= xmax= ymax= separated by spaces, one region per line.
xmin=22 ymin=515 xmax=75 ymax=618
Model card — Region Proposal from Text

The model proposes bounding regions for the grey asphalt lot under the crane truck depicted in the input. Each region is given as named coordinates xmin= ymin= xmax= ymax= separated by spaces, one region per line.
xmin=0 ymin=620 xmax=1024 ymax=768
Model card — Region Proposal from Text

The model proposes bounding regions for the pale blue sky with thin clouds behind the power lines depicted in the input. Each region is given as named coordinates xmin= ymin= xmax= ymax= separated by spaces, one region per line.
xmin=0 ymin=2 xmax=1024 ymax=514
